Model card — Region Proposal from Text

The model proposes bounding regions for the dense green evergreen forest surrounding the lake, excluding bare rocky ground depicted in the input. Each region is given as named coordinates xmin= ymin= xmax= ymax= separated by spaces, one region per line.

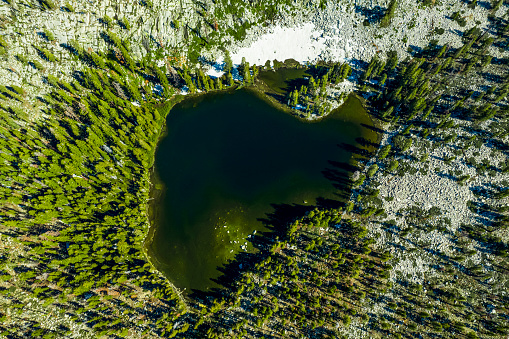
xmin=0 ymin=0 xmax=509 ymax=338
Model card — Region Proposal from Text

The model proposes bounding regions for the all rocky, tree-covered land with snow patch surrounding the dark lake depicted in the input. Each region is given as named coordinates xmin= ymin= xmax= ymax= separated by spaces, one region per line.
xmin=0 ymin=0 xmax=509 ymax=338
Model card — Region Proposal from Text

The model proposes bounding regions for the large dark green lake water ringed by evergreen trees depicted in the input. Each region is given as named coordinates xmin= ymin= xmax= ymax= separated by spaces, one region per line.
xmin=147 ymin=90 xmax=376 ymax=290
